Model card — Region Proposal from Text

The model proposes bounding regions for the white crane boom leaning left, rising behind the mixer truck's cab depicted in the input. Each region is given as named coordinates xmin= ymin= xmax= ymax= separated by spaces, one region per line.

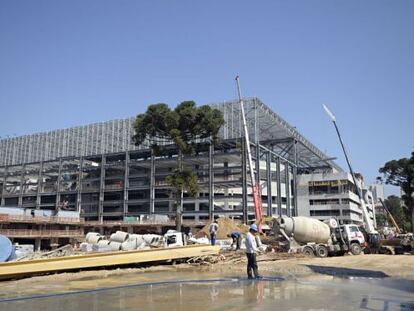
xmin=323 ymin=105 xmax=378 ymax=236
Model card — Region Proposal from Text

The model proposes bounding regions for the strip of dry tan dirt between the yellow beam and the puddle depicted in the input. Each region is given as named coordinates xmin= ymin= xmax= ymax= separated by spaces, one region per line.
xmin=9 ymin=251 xmax=414 ymax=285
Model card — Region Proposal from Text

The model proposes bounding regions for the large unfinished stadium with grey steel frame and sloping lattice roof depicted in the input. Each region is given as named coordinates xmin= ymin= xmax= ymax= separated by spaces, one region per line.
xmin=0 ymin=98 xmax=341 ymax=227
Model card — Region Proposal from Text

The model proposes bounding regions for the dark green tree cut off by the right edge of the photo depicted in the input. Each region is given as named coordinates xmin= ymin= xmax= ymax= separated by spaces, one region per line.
xmin=379 ymin=152 xmax=414 ymax=230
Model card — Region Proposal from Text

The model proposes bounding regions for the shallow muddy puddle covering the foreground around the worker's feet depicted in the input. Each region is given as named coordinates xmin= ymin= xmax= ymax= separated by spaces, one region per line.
xmin=0 ymin=270 xmax=414 ymax=311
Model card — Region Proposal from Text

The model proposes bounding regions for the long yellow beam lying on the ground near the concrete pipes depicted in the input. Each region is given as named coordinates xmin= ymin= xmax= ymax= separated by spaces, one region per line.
xmin=0 ymin=245 xmax=220 ymax=280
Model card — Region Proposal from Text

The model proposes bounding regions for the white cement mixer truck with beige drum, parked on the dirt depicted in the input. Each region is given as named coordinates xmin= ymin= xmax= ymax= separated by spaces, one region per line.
xmin=273 ymin=216 xmax=365 ymax=257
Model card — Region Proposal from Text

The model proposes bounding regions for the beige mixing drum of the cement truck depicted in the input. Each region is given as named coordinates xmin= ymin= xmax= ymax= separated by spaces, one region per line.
xmin=279 ymin=216 xmax=331 ymax=243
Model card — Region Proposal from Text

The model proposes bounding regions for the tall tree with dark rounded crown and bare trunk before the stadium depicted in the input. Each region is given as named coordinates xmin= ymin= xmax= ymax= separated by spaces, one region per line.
xmin=133 ymin=101 xmax=224 ymax=230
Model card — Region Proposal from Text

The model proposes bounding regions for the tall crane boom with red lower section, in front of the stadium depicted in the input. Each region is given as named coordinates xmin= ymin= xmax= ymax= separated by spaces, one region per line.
xmin=236 ymin=76 xmax=263 ymax=232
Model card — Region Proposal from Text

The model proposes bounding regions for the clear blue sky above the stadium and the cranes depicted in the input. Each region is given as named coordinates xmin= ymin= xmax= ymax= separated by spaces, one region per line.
xmin=0 ymin=0 xmax=414 ymax=196
